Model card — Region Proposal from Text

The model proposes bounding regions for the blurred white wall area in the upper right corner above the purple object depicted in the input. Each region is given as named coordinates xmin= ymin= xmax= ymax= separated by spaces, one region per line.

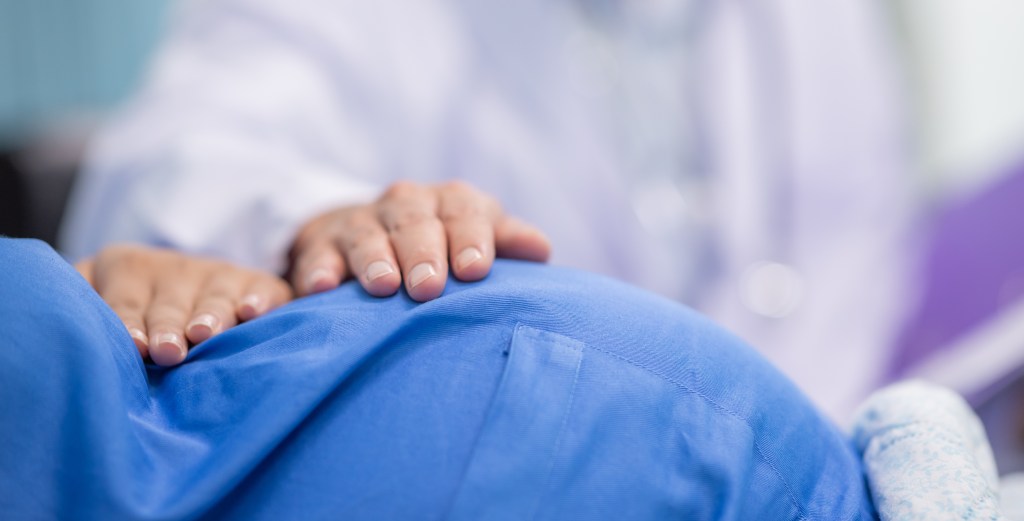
xmin=894 ymin=0 xmax=1024 ymax=200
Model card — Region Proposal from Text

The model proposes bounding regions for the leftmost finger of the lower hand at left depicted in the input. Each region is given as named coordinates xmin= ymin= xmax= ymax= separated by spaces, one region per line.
xmin=92 ymin=253 xmax=153 ymax=358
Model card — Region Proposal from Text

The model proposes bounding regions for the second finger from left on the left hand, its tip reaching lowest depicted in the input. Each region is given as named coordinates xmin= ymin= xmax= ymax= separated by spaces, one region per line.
xmin=145 ymin=269 xmax=205 ymax=365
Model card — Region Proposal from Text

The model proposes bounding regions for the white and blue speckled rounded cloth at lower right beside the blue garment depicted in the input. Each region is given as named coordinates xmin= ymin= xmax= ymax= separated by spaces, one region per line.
xmin=853 ymin=381 xmax=1008 ymax=521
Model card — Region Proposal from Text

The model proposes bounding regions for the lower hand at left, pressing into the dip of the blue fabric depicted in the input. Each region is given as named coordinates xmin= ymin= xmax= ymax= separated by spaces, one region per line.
xmin=75 ymin=246 xmax=292 ymax=365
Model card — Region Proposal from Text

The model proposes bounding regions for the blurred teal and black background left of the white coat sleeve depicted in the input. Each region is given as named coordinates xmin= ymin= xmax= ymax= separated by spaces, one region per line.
xmin=0 ymin=0 xmax=170 ymax=244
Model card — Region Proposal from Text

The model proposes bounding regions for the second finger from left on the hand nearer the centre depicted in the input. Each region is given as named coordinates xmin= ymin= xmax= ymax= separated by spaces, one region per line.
xmin=337 ymin=207 xmax=401 ymax=297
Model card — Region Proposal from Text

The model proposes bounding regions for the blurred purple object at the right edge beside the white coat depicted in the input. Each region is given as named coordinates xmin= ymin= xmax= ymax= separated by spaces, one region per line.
xmin=890 ymin=161 xmax=1024 ymax=386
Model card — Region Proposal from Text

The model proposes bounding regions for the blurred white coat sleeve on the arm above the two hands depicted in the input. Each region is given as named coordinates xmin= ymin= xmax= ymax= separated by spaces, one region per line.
xmin=61 ymin=1 xmax=383 ymax=272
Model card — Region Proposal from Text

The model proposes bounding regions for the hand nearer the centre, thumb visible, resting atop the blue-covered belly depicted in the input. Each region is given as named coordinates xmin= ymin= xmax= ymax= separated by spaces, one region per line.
xmin=289 ymin=181 xmax=551 ymax=302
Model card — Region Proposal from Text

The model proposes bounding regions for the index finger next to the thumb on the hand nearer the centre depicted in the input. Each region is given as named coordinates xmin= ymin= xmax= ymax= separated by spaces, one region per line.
xmin=438 ymin=183 xmax=500 ymax=280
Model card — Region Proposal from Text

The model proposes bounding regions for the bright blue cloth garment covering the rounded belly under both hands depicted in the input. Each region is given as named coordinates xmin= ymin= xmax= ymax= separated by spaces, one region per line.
xmin=0 ymin=240 xmax=873 ymax=521
